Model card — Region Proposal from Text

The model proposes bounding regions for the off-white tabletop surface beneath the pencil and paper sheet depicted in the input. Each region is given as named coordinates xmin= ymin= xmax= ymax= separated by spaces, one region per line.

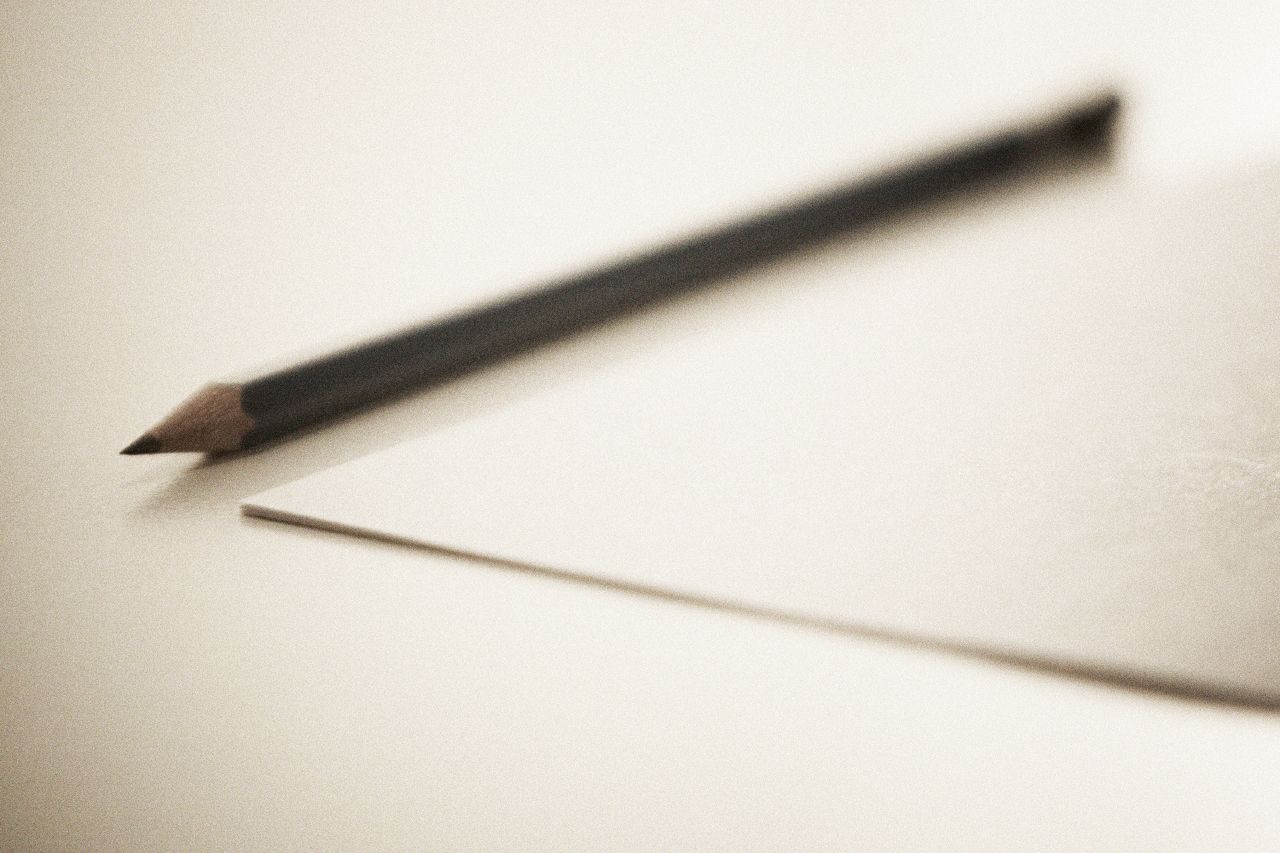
xmin=0 ymin=1 xmax=1280 ymax=850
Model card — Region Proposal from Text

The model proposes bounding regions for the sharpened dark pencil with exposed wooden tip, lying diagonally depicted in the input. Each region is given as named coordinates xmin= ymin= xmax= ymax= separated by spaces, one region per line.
xmin=122 ymin=92 xmax=1120 ymax=455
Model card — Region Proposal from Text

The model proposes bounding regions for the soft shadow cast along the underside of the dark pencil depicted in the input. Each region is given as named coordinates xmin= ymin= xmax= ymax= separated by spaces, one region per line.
xmin=133 ymin=159 xmax=1111 ymax=516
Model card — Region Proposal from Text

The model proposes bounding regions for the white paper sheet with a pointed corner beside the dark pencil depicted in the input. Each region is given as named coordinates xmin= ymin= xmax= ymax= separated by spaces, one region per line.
xmin=244 ymin=167 xmax=1280 ymax=702
